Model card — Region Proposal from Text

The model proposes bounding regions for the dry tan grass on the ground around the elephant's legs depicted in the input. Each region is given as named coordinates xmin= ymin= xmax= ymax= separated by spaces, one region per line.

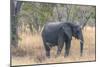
xmin=11 ymin=27 xmax=95 ymax=65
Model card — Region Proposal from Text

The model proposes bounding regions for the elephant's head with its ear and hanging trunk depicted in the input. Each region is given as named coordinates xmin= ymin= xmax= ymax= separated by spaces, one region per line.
xmin=63 ymin=24 xmax=84 ymax=56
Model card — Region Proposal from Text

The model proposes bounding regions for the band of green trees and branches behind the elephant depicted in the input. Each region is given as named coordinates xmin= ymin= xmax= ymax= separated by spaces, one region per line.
xmin=18 ymin=2 xmax=96 ymax=32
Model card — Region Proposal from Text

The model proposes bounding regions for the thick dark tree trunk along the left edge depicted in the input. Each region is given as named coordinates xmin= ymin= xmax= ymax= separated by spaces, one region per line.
xmin=10 ymin=0 xmax=22 ymax=47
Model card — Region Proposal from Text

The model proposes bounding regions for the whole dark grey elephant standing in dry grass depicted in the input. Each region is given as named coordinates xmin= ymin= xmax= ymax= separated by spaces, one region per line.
xmin=42 ymin=22 xmax=83 ymax=58
